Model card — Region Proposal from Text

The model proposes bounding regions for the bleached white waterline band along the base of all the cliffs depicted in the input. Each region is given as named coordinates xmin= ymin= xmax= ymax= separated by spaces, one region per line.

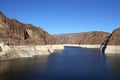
xmin=0 ymin=43 xmax=120 ymax=60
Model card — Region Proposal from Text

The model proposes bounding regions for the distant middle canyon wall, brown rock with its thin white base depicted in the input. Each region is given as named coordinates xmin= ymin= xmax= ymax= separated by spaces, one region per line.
xmin=54 ymin=31 xmax=110 ymax=49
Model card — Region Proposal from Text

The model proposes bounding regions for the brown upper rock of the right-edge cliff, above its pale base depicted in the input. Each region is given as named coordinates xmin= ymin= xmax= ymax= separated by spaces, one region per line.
xmin=103 ymin=28 xmax=120 ymax=45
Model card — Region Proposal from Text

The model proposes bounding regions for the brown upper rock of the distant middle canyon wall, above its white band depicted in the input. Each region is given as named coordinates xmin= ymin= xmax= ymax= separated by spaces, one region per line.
xmin=54 ymin=31 xmax=109 ymax=44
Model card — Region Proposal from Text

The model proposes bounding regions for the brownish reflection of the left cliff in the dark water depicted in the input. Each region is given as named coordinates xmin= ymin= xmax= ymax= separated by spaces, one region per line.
xmin=0 ymin=56 xmax=48 ymax=80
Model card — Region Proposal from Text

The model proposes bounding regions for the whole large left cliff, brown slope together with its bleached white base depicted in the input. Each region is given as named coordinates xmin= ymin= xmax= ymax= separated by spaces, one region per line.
xmin=0 ymin=12 xmax=64 ymax=60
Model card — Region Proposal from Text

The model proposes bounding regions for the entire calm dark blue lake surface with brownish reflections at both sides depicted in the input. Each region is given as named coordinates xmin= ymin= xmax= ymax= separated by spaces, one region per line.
xmin=0 ymin=47 xmax=120 ymax=80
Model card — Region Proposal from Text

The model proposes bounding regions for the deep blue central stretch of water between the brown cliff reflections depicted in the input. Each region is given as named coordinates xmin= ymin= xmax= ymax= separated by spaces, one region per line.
xmin=42 ymin=47 xmax=111 ymax=80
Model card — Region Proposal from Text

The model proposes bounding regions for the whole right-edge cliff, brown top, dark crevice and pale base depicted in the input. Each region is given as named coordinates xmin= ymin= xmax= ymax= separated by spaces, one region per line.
xmin=101 ymin=28 xmax=120 ymax=54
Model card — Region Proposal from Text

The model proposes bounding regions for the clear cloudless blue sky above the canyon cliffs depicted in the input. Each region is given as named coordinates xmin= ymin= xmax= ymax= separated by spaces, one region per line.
xmin=0 ymin=0 xmax=120 ymax=34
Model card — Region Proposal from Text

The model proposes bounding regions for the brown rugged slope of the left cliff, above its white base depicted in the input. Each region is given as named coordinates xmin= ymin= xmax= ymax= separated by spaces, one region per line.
xmin=0 ymin=12 xmax=61 ymax=45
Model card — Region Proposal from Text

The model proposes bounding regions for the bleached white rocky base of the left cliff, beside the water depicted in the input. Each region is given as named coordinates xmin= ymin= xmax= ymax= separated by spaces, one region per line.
xmin=0 ymin=43 xmax=64 ymax=60
